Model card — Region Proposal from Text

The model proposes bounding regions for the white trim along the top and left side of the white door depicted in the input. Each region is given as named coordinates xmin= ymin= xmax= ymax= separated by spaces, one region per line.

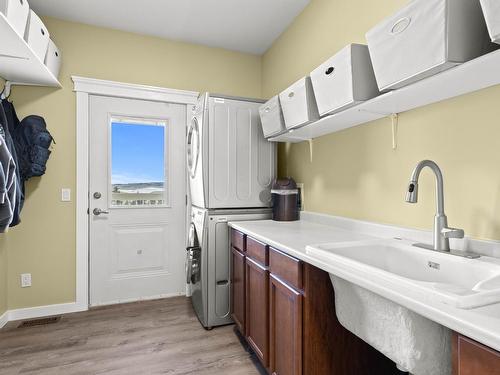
xmin=71 ymin=76 xmax=199 ymax=307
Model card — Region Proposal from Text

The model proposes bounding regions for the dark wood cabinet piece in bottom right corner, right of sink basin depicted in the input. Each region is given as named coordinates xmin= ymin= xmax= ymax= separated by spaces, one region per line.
xmin=452 ymin=333 xmax=500 ymax=375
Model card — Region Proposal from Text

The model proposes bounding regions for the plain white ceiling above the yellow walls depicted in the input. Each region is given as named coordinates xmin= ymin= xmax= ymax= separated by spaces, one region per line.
xmin=29 ymin=0 xmax=310 ymax=55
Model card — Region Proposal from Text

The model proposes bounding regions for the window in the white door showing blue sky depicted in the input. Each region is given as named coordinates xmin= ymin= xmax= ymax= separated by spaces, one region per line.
xmin=109 ymin=118 xmax=168 ymax=208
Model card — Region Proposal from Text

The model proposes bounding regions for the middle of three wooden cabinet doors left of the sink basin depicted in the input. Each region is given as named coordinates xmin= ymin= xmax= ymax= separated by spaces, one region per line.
xmin=245 ymin=257 xmax=269 ymax=368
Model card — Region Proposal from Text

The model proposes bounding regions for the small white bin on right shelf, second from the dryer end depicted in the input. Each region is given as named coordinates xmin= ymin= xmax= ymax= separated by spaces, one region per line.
xmin=279 ymin=77 xmax=319 ymax=129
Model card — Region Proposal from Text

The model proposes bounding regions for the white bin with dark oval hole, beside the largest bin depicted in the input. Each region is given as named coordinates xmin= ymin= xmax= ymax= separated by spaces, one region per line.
xmin=311 ymin=44 xmax=379 ymax=116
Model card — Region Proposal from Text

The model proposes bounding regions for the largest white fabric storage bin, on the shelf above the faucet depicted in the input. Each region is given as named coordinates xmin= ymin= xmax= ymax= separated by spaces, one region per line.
xmin=366 ymin=0 xmax=490 ymax=90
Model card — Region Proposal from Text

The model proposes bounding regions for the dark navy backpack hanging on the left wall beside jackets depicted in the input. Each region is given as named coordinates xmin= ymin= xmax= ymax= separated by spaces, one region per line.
xmin=14 ymin=116 xmax=54 ymax=181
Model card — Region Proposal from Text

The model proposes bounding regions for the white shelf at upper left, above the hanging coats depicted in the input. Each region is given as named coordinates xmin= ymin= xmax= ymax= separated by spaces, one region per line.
xmin=0 ymin=13 xmax=61 ymax=87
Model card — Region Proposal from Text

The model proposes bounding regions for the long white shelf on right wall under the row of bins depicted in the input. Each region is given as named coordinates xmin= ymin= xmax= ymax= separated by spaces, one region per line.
xmin=269 ymin=50 xmax=500 ymax=143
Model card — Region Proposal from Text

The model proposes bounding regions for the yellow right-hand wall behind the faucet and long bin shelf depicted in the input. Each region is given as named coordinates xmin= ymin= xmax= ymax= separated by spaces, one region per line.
xmin=262 ymin=0 xmax=500 ymax=240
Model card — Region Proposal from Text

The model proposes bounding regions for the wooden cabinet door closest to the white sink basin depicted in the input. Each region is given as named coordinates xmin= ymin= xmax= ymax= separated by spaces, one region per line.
xmin=269 ymin=274 xmax=303 ymax=375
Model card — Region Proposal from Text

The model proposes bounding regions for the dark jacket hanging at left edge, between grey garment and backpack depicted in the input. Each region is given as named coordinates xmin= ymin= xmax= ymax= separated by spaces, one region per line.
xmin=0 ymin=100 xmax=24 ymax=227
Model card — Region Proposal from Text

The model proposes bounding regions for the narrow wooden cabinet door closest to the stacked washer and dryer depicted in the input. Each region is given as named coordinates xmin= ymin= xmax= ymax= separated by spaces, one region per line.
xmin=231 ymin=247 xmax=245 ymax=335
